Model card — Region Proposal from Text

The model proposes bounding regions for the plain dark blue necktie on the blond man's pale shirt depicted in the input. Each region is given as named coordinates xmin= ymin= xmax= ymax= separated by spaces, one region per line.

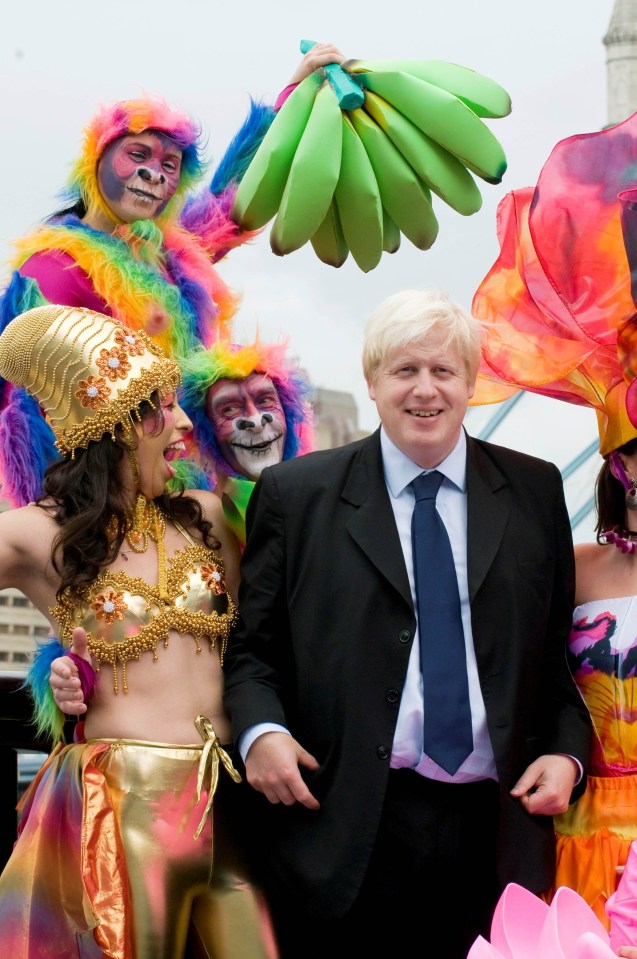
xmin=411 ymin=470 xmax=473 ymax=775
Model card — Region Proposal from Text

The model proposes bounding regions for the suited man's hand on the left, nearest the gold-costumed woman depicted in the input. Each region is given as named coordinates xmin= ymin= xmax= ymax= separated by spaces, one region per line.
xmin=245 ymin=732 xmax=320 ymax=809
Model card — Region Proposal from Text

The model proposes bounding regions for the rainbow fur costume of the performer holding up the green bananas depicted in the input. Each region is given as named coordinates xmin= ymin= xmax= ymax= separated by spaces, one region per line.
xmin=0 ymin=99 xmax=274 ymax=506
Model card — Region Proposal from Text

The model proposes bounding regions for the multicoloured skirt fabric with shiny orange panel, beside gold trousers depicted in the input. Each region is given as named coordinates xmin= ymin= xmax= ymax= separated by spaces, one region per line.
xmin=0 ymin=743 xmax=132 ymax=959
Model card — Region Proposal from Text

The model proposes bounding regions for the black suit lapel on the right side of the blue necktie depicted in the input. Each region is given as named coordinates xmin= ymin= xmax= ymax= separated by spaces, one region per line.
xmin=467 ymin=436 xmax=509 ymax=602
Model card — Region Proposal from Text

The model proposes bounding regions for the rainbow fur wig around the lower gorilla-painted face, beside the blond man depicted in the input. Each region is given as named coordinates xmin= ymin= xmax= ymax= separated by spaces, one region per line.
xmin=180 ymin=337 xmax=314 ymax=476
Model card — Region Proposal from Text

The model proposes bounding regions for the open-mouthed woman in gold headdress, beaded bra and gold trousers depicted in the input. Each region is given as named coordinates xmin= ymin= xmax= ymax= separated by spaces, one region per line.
xmin=0 ymin=305 xmax=277 ymax=959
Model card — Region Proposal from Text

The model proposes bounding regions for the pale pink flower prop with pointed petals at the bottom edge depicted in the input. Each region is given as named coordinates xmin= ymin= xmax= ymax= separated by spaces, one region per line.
xmin=467 ymin=883 xmax=616 ymax=959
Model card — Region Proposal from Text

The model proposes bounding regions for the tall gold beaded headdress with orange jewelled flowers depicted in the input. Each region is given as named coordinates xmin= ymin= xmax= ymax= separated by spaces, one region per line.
xmin=0 ymin=305 xmax=181 ymax=453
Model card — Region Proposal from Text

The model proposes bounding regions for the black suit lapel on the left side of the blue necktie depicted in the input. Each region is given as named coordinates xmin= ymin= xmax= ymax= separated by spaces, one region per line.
xmin=341 ymin=430 xmax=413 ymax=609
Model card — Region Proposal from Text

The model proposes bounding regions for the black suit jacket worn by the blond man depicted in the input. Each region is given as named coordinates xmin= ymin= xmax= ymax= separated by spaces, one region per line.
xmin=225 ymin=432 xmax=590 ymax=917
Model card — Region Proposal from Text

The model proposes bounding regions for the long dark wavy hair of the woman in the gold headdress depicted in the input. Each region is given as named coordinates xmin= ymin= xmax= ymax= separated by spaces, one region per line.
xmin=38 ymin=394 xmax=220 ymax=599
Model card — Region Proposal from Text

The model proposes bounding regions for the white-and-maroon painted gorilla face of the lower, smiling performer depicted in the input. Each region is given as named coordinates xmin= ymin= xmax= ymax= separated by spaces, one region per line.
xmin=206 ymin=373 xmax=286 ymax=480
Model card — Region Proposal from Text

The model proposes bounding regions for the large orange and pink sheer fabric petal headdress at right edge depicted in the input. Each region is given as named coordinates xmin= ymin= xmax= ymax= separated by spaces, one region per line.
xmin=472 ymin=114 xmax=637 ymax=454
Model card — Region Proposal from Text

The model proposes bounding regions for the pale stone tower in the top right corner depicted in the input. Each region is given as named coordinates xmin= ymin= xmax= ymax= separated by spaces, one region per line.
xmin=603 ymin=0 xmax=637 ymax=126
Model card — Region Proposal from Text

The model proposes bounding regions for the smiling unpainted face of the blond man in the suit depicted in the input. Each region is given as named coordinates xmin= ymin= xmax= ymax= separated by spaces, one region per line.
xmin=367 ymin=329 xmax=473 ymax=469
